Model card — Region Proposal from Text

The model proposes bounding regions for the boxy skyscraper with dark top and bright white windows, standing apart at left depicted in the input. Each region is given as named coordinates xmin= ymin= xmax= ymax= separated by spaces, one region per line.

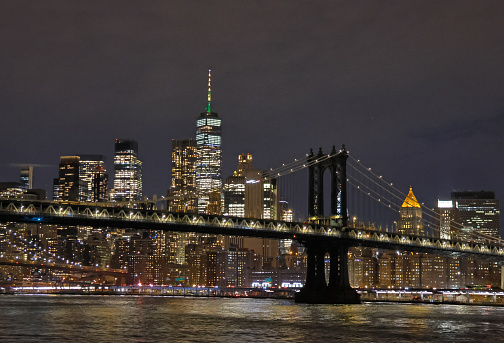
xmin=111 ymin=139 xmax=142 ymax=202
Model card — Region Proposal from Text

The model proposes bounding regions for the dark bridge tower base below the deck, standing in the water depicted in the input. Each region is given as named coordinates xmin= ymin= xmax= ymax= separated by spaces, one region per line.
xmin=295 ymin=243 xmax=360 ymax=304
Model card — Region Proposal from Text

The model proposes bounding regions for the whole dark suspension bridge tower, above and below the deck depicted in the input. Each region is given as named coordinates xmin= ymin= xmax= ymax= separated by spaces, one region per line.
xmin=296 ymin=145 xmax=360 ymax=304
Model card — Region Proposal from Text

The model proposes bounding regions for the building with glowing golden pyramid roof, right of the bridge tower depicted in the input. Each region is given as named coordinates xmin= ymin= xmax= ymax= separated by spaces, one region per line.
xmin=397 ymin=187 xmax=425 ymax=236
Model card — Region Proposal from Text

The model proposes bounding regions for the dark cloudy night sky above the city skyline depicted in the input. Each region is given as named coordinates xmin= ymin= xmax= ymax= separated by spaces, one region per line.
xmin=0 ymin=0 xmax=504 ymax=222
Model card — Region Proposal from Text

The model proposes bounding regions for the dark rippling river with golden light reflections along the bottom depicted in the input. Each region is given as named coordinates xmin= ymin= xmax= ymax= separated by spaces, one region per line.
xmin=0 ymin=295 xmax=504 ymax=343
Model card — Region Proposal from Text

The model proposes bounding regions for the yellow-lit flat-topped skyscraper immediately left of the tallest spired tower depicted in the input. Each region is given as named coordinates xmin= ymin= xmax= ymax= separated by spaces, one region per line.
xmin=168 ymin=139 xmax=198 ymax=213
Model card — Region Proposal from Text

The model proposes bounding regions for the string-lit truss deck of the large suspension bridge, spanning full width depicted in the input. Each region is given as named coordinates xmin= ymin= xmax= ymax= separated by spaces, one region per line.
xmin=0 ymin=199 xmax=504 ymax=261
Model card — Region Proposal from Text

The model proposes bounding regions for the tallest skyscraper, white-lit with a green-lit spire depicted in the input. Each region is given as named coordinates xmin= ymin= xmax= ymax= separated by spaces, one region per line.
xmin=196 ymin=70 xmax=222 ymax=213
